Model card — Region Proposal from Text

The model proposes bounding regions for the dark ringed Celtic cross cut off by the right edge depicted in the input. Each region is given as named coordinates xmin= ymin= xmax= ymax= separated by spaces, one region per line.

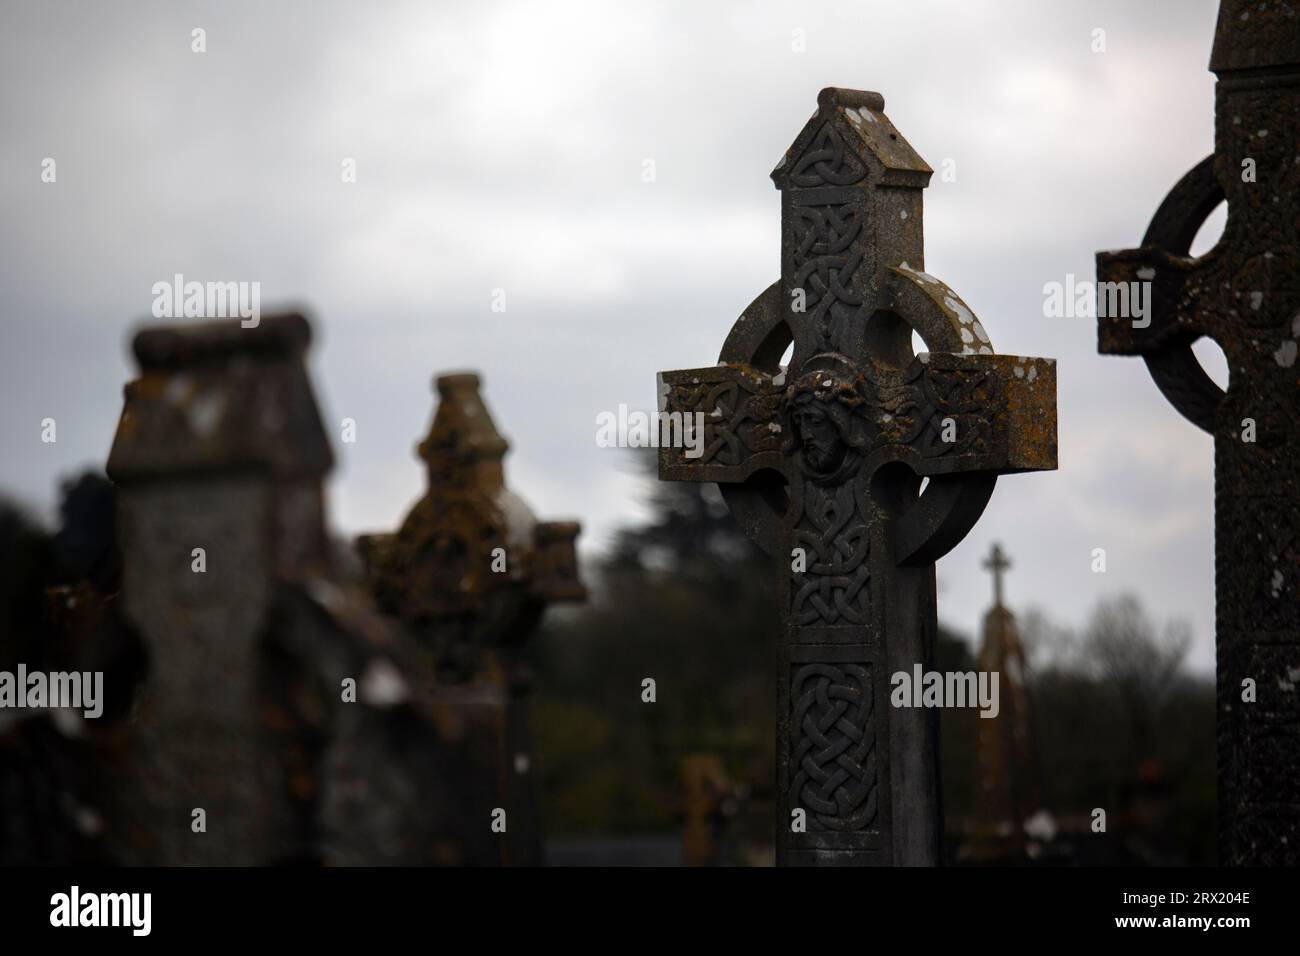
xmin=1097 ymin=0 xmax=1300 ymax=865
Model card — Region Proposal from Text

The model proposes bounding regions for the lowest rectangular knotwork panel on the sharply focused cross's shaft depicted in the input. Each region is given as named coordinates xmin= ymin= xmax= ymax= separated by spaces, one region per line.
xmin=789 ymin=663 xmax=876 ymax=831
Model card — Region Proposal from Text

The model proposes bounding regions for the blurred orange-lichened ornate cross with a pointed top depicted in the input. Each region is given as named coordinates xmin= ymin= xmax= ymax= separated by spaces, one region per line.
xmin=358 ymin=373 xmax=586 ymax=866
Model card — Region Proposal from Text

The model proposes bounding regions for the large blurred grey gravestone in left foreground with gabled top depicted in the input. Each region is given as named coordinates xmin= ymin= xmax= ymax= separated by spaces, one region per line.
xmin=96 ymin=316 xmax=499 ymax=865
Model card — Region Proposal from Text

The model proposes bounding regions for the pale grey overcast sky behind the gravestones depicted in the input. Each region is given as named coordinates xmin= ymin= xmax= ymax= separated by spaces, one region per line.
xmin=0 ymin=0 xmax=1223 ymax=671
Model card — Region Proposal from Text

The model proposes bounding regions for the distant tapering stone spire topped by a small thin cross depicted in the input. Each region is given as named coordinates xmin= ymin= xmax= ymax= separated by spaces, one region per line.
xmin=967 ymin=544 xmax=1043 ymax=858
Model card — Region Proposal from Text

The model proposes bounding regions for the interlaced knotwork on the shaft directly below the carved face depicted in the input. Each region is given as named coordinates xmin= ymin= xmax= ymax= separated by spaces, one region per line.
xmin=790 ymin=483 xmax=871 ymax=626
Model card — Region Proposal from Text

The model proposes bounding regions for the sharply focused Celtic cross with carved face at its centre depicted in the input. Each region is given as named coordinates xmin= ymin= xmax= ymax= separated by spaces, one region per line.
xmin=659 ymin=88 xmax=1056 ymax=865
